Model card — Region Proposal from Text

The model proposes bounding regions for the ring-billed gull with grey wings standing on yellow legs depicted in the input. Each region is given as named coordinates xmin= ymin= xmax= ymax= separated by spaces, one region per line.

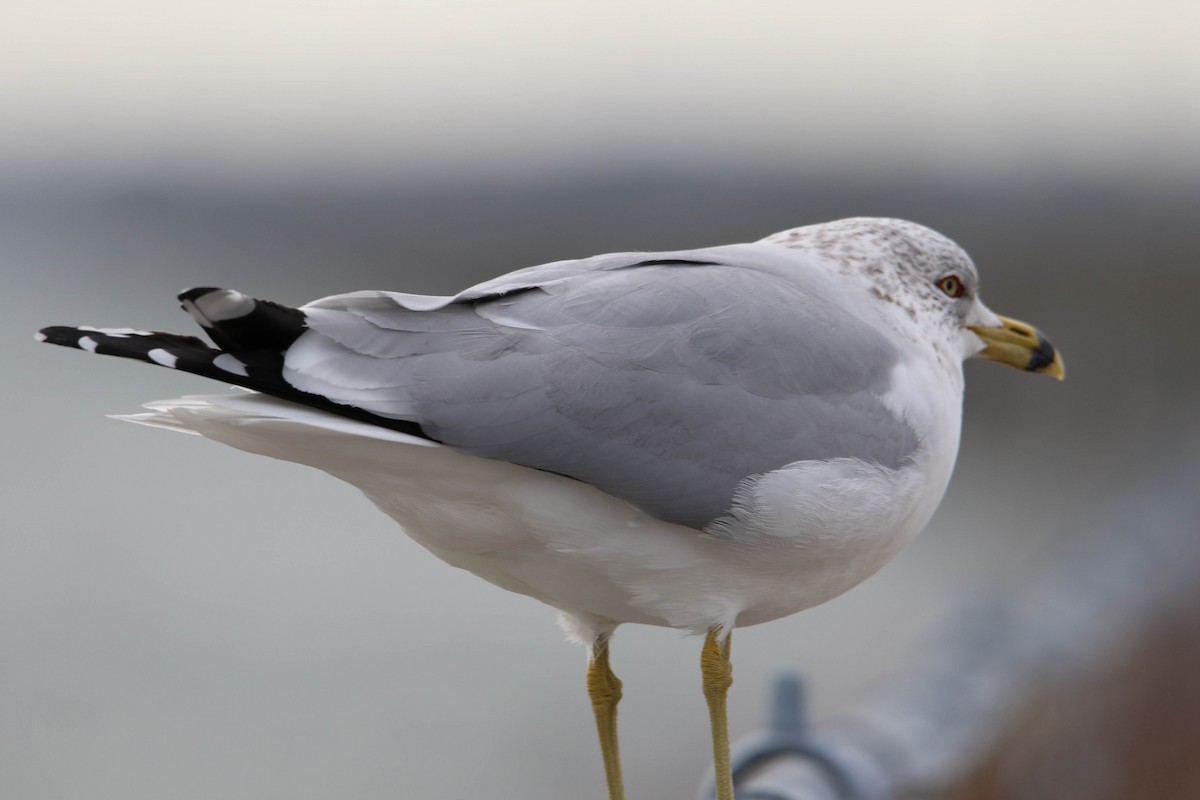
xmin=38 ymin=218 xmax=1062 ymax=800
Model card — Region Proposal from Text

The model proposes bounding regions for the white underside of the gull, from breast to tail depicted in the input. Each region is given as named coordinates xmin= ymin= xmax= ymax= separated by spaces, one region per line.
xmin=126 ymin=395 xmax=953 ymax=632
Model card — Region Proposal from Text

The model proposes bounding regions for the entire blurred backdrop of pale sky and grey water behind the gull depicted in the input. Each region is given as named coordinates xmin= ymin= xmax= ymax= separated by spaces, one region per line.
xmin=0 ymin=0 xmax=1200 ymax=800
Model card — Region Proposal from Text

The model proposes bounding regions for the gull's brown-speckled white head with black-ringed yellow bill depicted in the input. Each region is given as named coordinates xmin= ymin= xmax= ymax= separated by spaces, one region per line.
xmin=762 ymin=217 xmax=1063 ymax=380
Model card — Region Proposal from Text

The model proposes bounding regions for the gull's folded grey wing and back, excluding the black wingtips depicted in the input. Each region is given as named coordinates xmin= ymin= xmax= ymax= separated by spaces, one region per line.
xmin=284 ymin=245 xmax=916 ymax=528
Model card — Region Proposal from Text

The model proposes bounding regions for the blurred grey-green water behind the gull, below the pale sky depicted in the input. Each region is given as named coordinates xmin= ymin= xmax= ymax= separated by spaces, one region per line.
xmin=0 ymin=166 xmax=1200 ymax=800
